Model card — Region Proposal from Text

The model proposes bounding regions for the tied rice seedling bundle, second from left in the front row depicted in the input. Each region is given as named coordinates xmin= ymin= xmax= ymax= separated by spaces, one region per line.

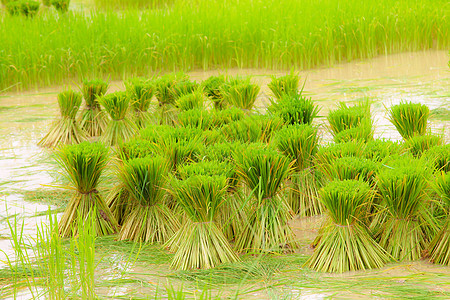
xmin=118 ymin=156 xmax=180 ymax=243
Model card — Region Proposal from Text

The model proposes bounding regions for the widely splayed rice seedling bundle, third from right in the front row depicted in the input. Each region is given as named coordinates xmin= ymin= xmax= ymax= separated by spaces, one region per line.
xmin=307 ymin=180 xmax=389 ymax=273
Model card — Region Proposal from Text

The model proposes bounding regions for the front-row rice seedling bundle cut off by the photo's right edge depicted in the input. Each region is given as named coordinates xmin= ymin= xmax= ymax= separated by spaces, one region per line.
xmin=428 ymin=172 xmax=450 ymax=266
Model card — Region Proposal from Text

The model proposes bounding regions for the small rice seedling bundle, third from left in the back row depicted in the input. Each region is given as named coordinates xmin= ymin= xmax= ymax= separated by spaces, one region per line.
xmin=98 ymin=92 xmax=137 ymax=146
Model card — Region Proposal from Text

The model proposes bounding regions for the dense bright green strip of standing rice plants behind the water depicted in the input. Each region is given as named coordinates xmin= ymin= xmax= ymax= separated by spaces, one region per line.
xmin=0 ymin=0 xmax=450 ymax=91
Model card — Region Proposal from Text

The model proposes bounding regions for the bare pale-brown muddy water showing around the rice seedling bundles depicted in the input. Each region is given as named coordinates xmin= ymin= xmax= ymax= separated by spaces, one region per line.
xmin=0 ymin=51 xmax=450 ymax=299
